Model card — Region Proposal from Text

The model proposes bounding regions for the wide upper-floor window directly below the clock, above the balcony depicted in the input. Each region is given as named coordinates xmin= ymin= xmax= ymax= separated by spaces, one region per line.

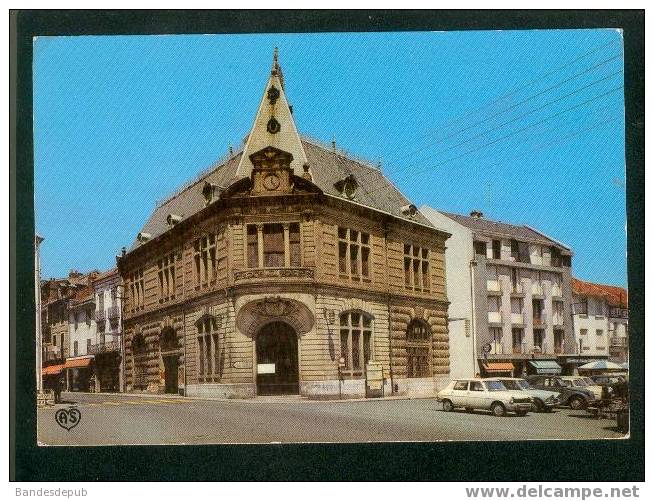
xmin=246 ymin=223 xmax=302 ymax=268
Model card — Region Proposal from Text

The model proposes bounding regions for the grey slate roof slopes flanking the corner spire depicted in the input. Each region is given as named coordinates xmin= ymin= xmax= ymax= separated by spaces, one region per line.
xmin=130 ymin=138 xmax=434 ymax=251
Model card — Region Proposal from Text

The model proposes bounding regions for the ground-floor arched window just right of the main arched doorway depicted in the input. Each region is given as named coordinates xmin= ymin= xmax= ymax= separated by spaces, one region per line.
xmin=340 ymin=311 xmax=372 ymax=376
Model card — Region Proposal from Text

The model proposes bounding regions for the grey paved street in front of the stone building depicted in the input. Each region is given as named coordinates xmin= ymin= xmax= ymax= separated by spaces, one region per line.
xmin=38 ymin=393 xmax=622 ymax=445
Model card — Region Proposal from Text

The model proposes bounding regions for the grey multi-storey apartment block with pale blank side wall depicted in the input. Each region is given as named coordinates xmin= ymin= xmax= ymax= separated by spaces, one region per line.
xmin=421 ymin=207 xmax=578 ymax=377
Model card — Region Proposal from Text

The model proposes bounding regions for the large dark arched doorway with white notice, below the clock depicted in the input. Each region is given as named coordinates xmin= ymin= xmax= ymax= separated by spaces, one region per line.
xmin=256 ymin=322 xmax=300 ymax=395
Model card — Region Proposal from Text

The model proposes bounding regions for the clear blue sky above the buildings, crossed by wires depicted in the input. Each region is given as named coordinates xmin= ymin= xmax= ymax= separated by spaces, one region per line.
xmin=34 ymin=30 xmax=627 ymax=285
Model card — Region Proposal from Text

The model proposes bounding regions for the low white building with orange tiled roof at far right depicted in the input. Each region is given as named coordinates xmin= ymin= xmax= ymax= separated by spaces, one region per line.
xmin=572 ymin=278 xmax=629 ymax=363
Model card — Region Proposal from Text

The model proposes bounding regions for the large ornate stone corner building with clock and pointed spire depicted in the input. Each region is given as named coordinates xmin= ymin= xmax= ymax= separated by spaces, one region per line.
xmin=118 ymin=50 xmax=450 ymax=398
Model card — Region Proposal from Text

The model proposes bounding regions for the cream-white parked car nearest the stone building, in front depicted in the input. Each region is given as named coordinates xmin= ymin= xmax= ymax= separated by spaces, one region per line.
xmin=436 ymin=378 xmax=533 ymax=417
